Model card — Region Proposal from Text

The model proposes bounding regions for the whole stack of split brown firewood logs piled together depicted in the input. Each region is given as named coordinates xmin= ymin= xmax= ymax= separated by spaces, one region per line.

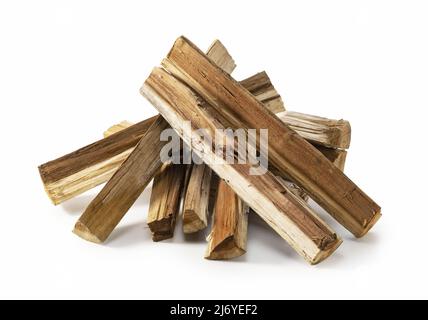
xmin=39 ymin=37 xmax=381 ymax=264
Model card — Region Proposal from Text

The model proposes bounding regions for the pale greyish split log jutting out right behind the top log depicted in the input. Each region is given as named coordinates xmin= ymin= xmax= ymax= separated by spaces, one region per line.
xmin=277 ymin=111 xmax=351 ymax=149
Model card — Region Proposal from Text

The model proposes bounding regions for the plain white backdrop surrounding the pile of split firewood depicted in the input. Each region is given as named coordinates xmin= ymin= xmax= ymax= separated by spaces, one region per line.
xmin=0 ymin=0 xmax=428 ymax=299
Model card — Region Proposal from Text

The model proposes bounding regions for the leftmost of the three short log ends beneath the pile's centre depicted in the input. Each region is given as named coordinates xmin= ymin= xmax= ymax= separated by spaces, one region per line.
xmin=147 ymin=164 xmax=186 ymax=241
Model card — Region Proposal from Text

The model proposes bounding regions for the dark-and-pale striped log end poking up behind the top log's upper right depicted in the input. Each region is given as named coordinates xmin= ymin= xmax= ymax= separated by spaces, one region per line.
xmin=241 ymin=71 xmax=285 ymax=113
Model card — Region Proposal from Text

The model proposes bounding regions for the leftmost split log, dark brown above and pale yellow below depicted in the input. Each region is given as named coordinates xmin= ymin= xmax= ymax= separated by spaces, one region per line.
xmin=39 ymin=118 xmax=155 ymax=204
